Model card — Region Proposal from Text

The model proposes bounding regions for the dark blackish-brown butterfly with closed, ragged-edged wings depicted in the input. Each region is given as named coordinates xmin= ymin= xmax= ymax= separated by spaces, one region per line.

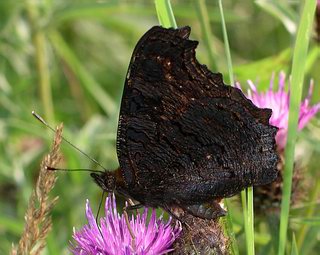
xmin=91 ymin=26 xmax=278 ymax=219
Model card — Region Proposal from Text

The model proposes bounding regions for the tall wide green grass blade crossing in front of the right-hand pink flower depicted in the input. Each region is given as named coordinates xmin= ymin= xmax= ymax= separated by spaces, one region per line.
xmin=278 ymin=0 xmax=316 ymax=255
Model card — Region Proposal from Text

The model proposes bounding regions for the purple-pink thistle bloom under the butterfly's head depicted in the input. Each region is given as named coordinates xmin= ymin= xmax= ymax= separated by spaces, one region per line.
xmin=71 ymin=195 xmax=181 ymax=255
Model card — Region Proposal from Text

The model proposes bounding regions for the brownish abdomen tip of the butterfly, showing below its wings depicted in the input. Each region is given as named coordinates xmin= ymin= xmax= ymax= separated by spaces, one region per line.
xmin=183 ymin=200 xmax=227 ymax=220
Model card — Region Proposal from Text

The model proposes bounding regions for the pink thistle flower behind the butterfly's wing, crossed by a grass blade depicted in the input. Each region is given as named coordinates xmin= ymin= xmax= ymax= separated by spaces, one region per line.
xmin=236 ymin=72 xmax=320 ymax=150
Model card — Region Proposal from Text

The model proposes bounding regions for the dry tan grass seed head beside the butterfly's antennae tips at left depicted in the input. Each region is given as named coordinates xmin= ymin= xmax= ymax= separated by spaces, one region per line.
xmin=11 ymin=125 xmax=63 ymax=255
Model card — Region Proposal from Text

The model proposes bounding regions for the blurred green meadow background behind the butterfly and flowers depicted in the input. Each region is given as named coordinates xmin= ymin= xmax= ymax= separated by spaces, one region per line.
xmin=0 ymin=0 xmax=320 ymax=254
